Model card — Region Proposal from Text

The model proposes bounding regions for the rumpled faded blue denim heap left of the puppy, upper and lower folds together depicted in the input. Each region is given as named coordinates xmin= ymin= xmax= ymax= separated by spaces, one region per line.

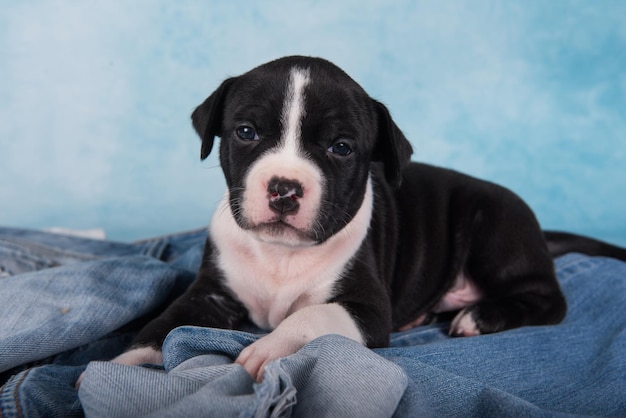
xmin=0 ymin=228 xmax=206 ymax=372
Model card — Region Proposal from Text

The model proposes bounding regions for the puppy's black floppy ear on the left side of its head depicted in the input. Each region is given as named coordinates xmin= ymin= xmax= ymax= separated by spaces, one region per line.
xmin=191 ymin=78 xmax=235 ymax=160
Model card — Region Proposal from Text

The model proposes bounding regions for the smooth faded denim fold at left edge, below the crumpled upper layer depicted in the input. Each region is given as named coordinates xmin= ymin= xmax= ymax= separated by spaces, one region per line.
xmin=0 ymin=256 xmax=181 ymax=372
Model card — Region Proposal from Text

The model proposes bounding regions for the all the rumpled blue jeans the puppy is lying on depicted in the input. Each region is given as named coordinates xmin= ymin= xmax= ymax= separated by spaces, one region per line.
xmin=0 ymin=228 xmax=626 ymax=417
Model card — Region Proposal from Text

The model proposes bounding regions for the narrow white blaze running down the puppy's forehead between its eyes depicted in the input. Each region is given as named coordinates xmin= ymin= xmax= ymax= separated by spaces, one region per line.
xmin=281 ymin=67 xmax=310 ymax=155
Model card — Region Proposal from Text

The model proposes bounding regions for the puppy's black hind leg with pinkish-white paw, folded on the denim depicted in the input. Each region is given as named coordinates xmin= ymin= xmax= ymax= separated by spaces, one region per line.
xmin=450 ymin=201 xmax=567 ymax=336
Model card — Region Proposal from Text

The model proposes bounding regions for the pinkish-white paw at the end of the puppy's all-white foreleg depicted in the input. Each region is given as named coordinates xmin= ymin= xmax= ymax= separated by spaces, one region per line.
xmin=235 ymin=331 xmax=305 ymax=382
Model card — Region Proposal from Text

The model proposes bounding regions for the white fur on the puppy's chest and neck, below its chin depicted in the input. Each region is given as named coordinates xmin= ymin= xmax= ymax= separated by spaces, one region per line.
xmin=211 ymin=180 xmax=373 ymax=329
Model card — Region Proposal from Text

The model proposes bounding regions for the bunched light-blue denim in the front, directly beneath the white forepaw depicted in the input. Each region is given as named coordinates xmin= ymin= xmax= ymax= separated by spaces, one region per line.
xmin=79 ymin=327 xmax=407 ymax=417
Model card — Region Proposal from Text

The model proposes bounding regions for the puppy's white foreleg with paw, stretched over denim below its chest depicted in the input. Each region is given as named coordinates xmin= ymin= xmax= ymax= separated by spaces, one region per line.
xmin=236 ymin=303 xmax=364 ymax=381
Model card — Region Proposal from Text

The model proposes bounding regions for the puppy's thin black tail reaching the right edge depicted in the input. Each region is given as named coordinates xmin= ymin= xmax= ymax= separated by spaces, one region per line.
xmin=543 ymin=231 xmax=626 ymax=261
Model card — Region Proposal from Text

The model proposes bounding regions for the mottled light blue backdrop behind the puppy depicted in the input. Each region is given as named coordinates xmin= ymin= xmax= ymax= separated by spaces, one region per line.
xmin=0 ymin=0 xmax=626 ymax=245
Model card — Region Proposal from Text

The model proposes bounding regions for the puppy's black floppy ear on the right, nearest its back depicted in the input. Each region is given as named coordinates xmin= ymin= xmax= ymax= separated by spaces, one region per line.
xmin=372 ymin=99 xmax=413 ymax=187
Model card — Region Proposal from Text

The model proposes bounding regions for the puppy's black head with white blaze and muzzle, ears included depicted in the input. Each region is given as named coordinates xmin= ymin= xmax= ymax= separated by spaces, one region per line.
xmin=192 ymin=56 xmax=412 ymax=246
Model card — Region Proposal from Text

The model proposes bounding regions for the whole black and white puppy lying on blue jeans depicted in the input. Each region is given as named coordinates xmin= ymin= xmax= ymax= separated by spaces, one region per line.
xmin=108 ymin=56 xmax=624 ymax=379
